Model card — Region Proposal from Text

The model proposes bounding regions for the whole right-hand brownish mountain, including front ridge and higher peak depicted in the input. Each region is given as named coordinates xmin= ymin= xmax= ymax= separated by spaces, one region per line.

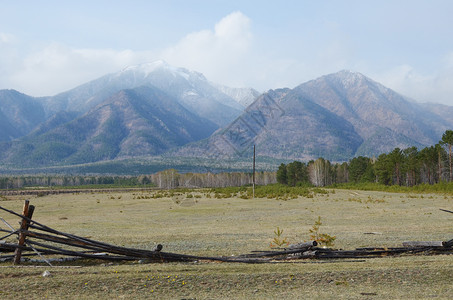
xmin=170 ymin=71 xmax=453 ymax=161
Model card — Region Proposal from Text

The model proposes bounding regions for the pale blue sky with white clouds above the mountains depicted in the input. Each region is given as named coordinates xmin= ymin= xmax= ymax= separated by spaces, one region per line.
xmin=0 ymin=0 xmax=453 ymax=106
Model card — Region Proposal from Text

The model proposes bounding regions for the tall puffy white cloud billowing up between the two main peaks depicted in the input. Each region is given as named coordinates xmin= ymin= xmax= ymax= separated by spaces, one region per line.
xmin=156 ymin=12 xmax=311 ymax=91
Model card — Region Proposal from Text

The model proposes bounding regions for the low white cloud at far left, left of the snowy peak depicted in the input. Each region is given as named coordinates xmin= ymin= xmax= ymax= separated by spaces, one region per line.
xmin=2 ymin=43 xmax=154 ymax=96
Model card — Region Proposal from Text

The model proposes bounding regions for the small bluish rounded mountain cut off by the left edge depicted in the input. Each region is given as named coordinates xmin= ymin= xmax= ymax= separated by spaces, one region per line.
xmin=0 ymin=90 xmax=45 ymax=141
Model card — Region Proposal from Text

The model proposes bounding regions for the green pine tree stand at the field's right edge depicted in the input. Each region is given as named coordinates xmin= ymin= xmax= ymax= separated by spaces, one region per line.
xmin=277 ymin=130 xmax=453 ymax=186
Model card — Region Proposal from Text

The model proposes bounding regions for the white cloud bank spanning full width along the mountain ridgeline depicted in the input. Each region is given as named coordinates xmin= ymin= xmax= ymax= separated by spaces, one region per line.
xmin=0 ymin=11 xmax=453 ymax=105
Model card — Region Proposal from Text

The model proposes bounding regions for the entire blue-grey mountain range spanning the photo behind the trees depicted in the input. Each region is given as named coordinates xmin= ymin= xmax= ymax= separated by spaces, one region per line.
xmin=0 ymin=61 xmax=453 ymax=168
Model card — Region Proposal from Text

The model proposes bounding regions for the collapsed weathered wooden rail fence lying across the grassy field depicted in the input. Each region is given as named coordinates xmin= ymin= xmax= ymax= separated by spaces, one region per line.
xmin=0 ymin=200 xmax=453 ymax=264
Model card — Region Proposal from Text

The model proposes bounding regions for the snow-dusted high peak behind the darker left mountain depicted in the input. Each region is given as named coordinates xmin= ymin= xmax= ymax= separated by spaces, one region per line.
xmin=45 ymin=60 xmax=251 ymax=127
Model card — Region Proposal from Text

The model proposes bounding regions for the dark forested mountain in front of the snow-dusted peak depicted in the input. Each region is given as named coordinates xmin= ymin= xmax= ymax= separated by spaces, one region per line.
xmin=0 ymin=87 xmax=216 ymax=166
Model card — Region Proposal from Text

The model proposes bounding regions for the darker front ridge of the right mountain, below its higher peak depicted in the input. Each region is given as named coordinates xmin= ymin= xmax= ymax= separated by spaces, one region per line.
xmin=176 ymin=89 xmax=362 ymax=160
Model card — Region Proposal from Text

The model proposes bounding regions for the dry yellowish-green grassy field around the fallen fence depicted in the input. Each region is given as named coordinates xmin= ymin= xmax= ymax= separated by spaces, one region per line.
xmin=0 ymin=189 xmax=453 ymax=299
